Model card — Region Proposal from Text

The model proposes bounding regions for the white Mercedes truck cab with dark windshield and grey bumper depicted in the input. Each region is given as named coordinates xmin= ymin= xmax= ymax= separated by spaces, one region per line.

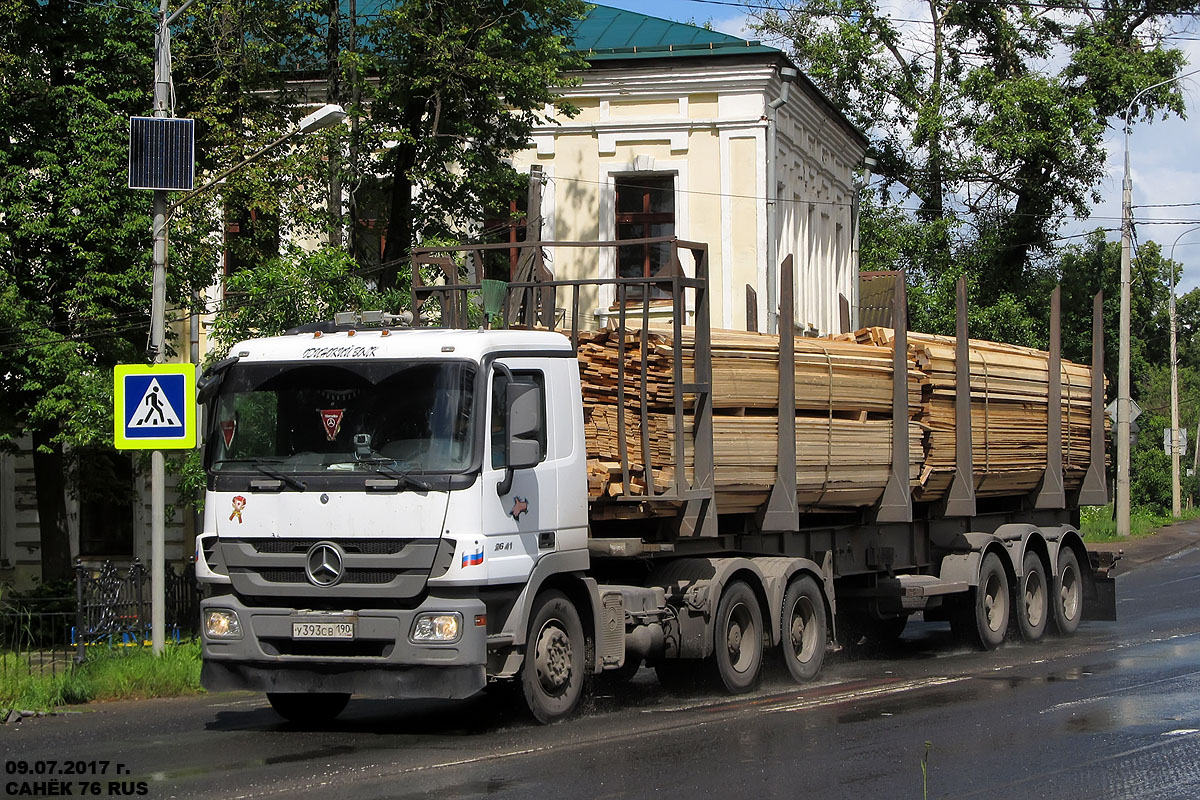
xmin=197 ymin=324 xmax=588 ymax=717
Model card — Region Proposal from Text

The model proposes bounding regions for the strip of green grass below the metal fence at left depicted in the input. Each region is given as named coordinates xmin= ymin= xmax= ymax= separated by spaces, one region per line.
xmin=0 ymin=640 xmax=202 ymax=711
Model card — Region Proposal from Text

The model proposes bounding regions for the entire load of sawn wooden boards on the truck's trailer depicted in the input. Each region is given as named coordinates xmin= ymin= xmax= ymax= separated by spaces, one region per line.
xmin=578 ymin=329 xmax=1091 ymax=513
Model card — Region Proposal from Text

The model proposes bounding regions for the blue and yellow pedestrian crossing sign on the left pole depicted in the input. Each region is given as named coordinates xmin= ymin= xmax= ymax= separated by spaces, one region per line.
xmin=113 ymin=363 xmax=196 ymax=450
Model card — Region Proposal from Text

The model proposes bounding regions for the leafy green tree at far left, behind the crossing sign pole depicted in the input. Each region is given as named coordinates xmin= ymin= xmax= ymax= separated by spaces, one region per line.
xmin=0 ymin=0 xmax=154 ymax=581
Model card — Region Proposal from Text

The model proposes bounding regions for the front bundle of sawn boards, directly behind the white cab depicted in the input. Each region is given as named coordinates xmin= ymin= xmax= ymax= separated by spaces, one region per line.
xmin=578 ymin=330 xmax=926 ymax=513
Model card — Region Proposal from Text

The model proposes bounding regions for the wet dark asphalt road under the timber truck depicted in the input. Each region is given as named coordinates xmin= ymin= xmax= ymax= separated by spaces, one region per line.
xmin=7 ymin=548 xmax=1200 ymax=800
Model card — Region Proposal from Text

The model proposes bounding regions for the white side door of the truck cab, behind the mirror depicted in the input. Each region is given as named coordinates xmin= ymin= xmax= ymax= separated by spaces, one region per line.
xmin=482 ymin=359 xmax=559 ymax=583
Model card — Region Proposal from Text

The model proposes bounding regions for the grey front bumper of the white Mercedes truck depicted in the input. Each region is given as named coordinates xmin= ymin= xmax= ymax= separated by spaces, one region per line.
xmin=200 ymin=595 xmax=487 ymax=699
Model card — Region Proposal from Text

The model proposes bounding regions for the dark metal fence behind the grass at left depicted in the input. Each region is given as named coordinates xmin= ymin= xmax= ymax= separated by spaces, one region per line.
xmin=0 ymin=560 xmax=200 ymax=674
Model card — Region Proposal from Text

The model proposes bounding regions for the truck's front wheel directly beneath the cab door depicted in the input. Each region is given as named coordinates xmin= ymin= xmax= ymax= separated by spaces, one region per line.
xmin=521 ymin=590 xmax=587 ymax=724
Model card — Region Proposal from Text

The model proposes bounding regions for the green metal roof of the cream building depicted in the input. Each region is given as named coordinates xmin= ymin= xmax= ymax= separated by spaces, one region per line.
xmin=572 ymin=6 xmax=780 ymax=61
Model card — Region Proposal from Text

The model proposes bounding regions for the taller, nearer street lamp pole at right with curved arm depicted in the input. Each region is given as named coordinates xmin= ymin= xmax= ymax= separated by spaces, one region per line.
xmin=1116 ymin=70 xmax=1200 ymax=536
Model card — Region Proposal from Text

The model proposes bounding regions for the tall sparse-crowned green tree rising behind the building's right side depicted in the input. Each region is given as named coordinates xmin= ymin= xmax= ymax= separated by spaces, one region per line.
xmin=758 ymin=0 xmax=1196 ymax=328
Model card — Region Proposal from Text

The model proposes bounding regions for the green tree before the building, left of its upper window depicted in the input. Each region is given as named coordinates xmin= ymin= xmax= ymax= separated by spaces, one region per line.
xmin=355 ymin=0 xmax=586 ymax=288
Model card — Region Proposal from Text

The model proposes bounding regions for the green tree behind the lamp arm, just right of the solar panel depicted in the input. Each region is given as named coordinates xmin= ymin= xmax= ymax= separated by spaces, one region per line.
xmin=168 ymin=0 xmax=333 ymax=302
